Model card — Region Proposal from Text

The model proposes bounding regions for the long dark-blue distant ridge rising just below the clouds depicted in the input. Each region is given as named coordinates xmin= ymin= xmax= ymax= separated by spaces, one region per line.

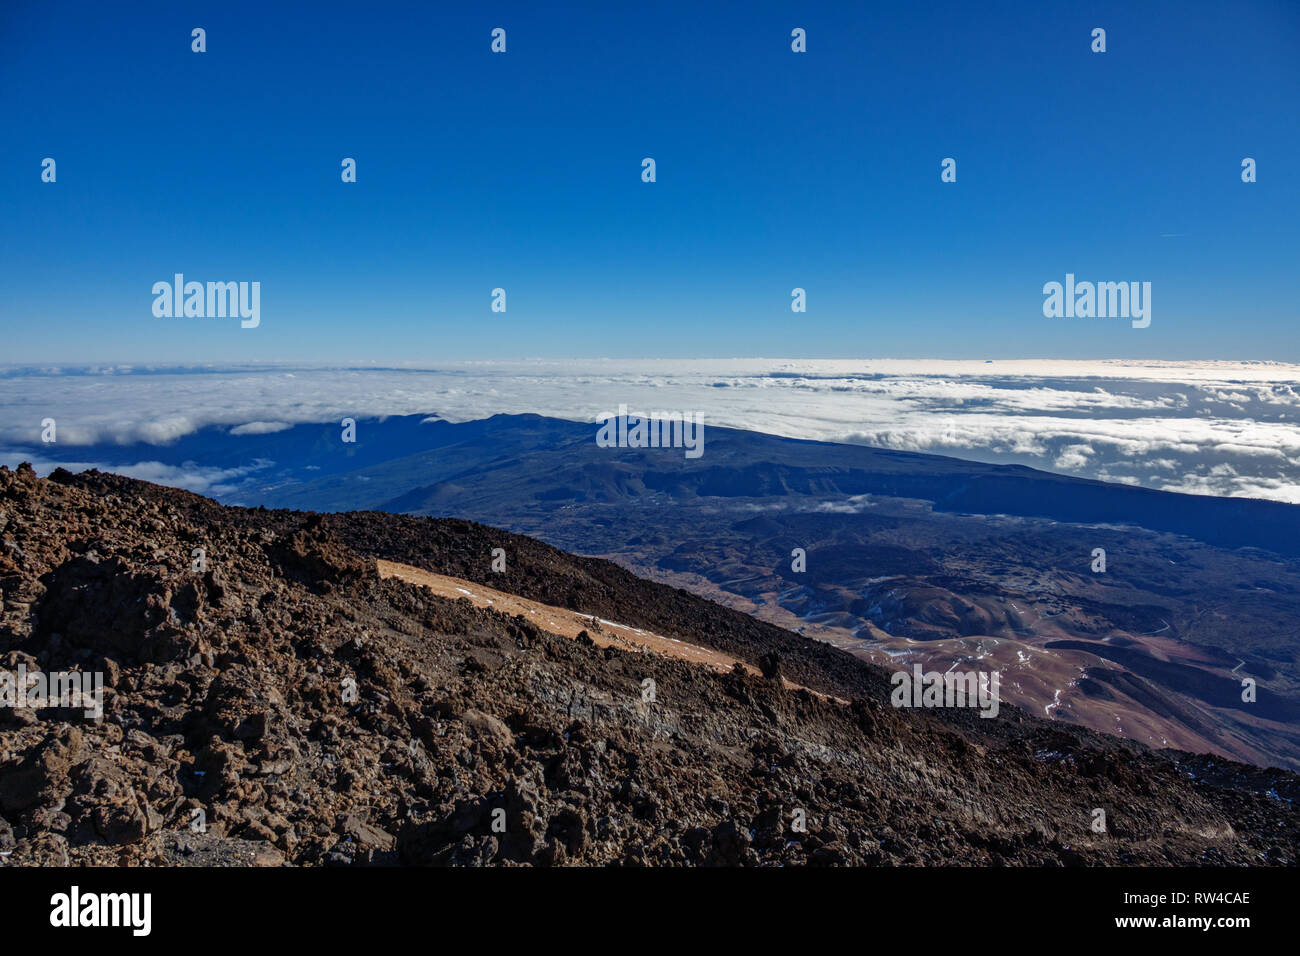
xmin=20 ymin=415 xmax=1300 ymax=558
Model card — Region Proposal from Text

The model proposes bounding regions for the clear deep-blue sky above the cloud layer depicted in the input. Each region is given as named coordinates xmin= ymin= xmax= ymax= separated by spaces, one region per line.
xmin=0 ymin=0 xmax=1300 ymax=363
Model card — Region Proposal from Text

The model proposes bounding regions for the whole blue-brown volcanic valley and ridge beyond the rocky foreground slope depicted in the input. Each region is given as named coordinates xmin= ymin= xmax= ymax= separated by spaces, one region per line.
xmin=226 ymin=415 xmax=1300 ymax=770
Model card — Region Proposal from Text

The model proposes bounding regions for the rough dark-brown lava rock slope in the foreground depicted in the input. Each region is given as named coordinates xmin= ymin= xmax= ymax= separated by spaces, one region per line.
xmin=0 ymin=467 xmax=1300 ymax=865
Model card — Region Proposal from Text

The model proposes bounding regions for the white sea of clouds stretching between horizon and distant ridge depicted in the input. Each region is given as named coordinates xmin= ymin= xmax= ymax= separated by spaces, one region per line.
xmin=0 ymin=359 xmax=1300 ymax=503
